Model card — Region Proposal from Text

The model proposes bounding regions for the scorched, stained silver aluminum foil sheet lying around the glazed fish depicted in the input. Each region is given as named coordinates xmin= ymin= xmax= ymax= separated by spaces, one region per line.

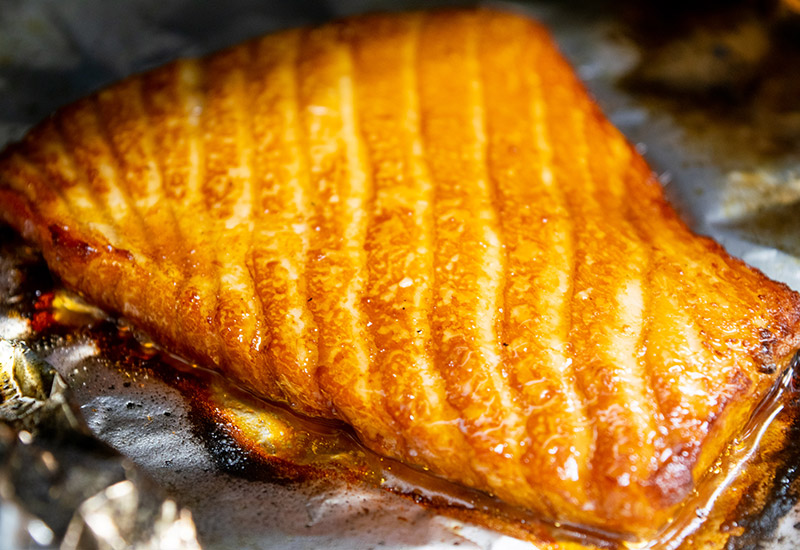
xmin=0 ymin=0 xmax=800 ymax=550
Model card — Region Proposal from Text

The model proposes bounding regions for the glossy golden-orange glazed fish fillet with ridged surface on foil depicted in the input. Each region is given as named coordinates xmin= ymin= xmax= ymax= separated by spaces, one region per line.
xmin=0 ymin=10 xmax=800 ymax=538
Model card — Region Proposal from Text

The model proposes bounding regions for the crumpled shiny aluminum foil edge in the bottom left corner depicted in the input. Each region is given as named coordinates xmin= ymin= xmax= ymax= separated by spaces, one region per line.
xmin=0 ymin=339 xmax=200 ymax=550
